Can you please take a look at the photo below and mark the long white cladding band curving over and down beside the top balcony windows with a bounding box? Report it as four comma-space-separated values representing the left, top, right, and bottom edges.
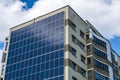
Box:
90, 29, 112, 62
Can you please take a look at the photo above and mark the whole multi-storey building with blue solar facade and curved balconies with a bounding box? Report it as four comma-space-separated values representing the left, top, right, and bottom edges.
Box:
0, 6, 120, 80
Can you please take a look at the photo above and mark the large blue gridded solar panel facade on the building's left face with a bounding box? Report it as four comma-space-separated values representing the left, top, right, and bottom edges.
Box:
5, 12, 64, 80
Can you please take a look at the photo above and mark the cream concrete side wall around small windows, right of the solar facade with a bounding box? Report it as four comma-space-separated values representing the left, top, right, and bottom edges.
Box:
65, 8, 87, 80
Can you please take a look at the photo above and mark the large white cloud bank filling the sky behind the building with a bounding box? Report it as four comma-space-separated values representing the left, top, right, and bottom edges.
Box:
0, 0, 120, 41
